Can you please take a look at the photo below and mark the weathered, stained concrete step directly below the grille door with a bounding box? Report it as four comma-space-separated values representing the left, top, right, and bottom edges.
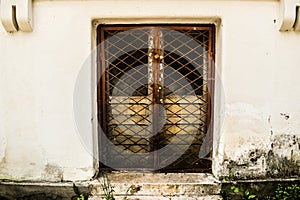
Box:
89, 173, 222, 200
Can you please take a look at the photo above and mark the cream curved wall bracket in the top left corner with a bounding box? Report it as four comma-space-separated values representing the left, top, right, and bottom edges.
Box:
0, 0, 32, 32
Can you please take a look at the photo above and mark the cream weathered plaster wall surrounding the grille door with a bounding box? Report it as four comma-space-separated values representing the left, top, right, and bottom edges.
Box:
0, 0, 300, 181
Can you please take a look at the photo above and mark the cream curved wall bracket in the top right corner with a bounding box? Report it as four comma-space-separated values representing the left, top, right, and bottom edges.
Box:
279, 0, 300, 31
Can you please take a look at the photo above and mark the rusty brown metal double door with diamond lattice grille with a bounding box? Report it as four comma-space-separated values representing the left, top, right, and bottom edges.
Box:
98, 25, 214, 172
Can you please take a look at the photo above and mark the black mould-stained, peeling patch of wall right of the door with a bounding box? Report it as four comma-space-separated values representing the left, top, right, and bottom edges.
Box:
223, 134, 300, 180
